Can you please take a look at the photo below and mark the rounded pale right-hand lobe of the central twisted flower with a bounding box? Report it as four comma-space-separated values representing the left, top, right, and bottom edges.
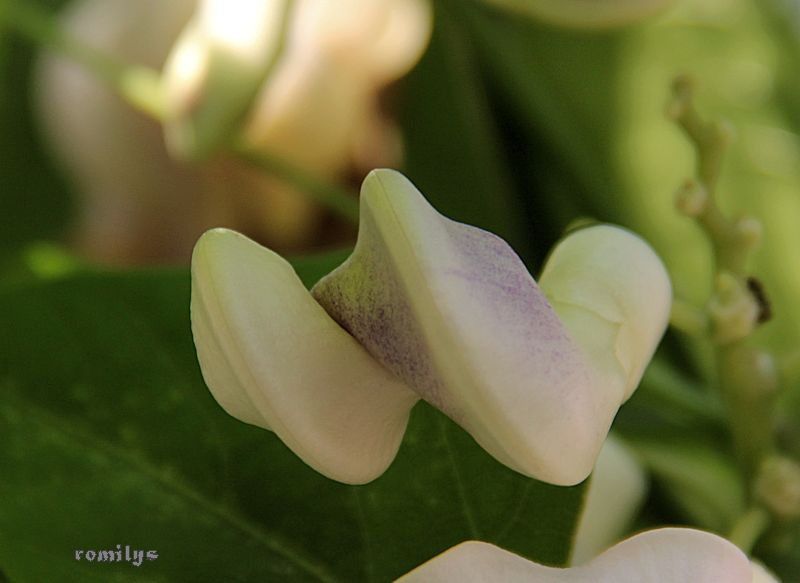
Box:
539, 225, 672, 402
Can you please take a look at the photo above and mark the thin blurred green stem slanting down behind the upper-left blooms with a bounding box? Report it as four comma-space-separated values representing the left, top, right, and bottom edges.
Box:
0, 0, 358, 225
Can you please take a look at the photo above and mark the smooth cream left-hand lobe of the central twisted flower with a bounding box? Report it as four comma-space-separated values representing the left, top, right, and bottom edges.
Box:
192, 229, 417, 483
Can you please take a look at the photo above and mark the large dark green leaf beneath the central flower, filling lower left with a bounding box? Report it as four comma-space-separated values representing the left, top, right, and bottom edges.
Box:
0, 254, 582, 583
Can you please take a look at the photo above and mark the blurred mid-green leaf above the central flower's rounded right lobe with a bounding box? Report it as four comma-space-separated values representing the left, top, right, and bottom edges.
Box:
463, 2, 619, 220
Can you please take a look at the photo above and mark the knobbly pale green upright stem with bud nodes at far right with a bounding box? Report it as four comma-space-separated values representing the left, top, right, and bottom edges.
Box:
668, 77, 778, 482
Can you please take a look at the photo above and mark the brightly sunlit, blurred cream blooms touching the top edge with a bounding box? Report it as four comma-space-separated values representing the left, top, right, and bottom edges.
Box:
164, 0, 432, 162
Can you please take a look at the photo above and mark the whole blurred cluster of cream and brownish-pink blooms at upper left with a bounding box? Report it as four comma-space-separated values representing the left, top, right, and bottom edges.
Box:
35, 0, 432, 263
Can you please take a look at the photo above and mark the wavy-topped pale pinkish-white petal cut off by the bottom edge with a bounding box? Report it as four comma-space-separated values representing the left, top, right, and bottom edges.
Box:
397, 528, 752, 583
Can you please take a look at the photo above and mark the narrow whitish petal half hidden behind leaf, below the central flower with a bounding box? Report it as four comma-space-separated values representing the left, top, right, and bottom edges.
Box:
572, 433, 647, 565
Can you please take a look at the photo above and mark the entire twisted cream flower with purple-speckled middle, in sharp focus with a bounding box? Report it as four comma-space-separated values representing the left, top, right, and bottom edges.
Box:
192, 170, 670, 484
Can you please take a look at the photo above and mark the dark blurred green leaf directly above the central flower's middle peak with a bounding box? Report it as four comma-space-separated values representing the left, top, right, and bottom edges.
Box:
403, 2, 529, 258
